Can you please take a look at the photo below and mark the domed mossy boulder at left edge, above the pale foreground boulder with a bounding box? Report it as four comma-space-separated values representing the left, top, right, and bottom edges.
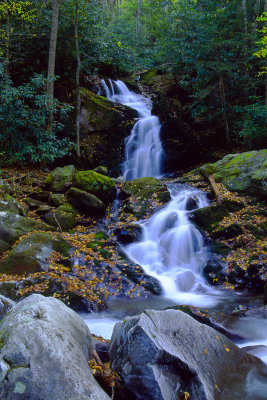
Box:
0, 232, 70, 275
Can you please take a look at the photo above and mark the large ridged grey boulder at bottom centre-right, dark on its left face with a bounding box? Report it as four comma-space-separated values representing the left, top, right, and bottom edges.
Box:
109, 310, 263, 400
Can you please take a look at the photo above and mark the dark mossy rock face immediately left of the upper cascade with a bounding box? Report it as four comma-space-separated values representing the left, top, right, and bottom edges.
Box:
80, 88, 137, 175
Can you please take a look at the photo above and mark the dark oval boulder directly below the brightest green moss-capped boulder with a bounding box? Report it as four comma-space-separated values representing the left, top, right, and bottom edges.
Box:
67, 188, 106, 216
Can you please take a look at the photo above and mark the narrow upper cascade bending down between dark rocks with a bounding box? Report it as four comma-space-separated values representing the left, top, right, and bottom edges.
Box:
102, 79, 163, 180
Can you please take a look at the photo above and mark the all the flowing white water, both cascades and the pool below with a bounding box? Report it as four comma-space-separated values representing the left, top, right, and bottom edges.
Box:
82, 80, 267, 400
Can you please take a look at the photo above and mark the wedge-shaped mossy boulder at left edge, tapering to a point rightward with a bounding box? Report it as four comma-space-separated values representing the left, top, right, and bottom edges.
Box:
0, 212, 54, 250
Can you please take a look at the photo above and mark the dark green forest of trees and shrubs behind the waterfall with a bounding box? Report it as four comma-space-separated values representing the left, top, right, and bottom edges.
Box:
0, 0, 267, 164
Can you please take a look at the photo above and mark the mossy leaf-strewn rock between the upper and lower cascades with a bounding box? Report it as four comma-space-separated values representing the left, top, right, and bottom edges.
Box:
121, 177, 171, 218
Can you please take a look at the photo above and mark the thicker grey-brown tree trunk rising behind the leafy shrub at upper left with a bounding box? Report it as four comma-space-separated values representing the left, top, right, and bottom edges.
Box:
47, 0, 61, 131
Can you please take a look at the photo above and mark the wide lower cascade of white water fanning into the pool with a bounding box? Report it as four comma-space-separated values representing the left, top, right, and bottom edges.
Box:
124, 185, 218, 304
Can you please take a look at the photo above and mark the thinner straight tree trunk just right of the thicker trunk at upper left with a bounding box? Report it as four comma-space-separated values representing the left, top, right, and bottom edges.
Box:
75, 0, 81, 158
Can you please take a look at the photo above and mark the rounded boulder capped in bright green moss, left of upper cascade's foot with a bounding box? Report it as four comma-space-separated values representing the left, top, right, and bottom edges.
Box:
73, 171, 116, 204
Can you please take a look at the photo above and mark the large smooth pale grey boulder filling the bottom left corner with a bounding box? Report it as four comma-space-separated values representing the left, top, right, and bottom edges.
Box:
0, 294, 110, 400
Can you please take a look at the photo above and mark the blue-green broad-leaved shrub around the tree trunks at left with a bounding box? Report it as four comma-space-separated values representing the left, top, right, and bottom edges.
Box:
0, 63, 70, 163
